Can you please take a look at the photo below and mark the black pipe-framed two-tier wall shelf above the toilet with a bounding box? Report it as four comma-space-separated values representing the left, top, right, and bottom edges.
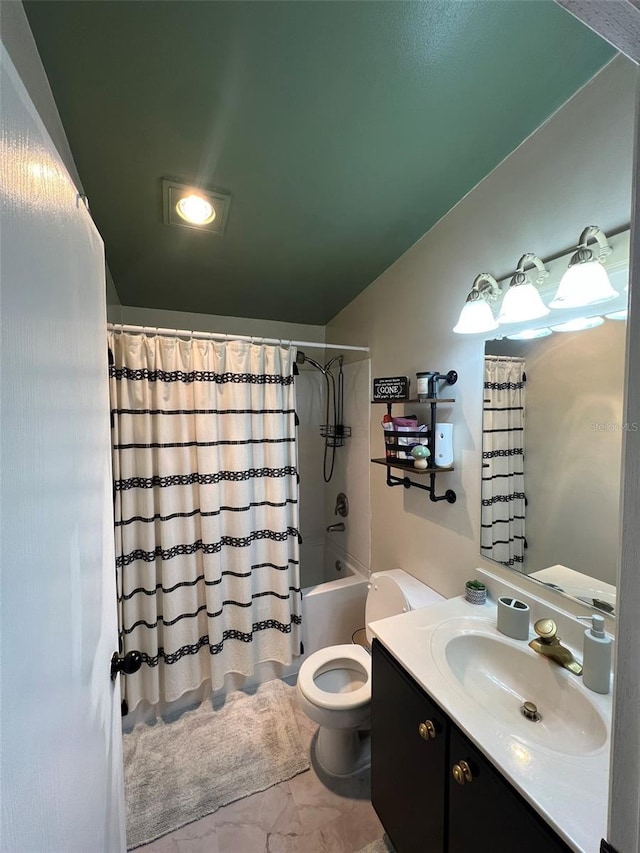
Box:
371, 370, 458, 504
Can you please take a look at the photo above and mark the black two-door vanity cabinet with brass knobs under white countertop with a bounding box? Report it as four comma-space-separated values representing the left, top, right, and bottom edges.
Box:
371, 640, 570, 853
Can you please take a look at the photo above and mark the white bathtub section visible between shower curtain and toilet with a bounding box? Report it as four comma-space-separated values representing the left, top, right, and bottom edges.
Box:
302, 541, 369, 656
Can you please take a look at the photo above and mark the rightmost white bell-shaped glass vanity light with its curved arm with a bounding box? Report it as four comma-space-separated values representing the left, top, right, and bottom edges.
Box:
549, 225, 618, 308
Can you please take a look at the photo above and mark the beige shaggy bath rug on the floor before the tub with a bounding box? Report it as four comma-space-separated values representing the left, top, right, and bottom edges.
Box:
123, 680, 309, 850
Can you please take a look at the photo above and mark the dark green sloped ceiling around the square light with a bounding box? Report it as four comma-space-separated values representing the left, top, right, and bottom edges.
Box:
25, 0, 613, 324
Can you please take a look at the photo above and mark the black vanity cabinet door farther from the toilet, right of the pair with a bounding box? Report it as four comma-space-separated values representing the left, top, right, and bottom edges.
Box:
448, 725, 570, 853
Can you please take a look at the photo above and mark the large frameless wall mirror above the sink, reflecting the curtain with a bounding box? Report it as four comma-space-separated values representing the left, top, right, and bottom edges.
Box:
480, 288, 624, 615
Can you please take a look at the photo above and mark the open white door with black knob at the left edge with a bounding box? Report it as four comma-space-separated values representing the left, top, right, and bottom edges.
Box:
0, 31, 126, 853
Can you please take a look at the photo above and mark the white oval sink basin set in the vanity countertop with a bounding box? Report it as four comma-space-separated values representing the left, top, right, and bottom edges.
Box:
432, 620, 607, 755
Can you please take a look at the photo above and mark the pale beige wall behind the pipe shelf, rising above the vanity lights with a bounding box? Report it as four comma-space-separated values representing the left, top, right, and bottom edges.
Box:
327, 57, 637, 596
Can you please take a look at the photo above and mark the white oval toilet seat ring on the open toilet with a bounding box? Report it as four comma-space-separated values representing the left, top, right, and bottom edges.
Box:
298, 643, 371, 711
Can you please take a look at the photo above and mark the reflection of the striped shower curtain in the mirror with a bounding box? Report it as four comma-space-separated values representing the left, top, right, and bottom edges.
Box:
480, 356, 526, 571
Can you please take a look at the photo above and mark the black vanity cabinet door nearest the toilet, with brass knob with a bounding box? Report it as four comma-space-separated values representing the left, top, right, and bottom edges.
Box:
371, 640, 444, 853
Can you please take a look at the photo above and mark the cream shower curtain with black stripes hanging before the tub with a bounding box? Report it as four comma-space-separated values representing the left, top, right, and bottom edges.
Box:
109, 332, 301, 711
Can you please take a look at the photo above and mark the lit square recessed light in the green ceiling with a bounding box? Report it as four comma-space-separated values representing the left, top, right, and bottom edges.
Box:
162, 178, 231, 234
